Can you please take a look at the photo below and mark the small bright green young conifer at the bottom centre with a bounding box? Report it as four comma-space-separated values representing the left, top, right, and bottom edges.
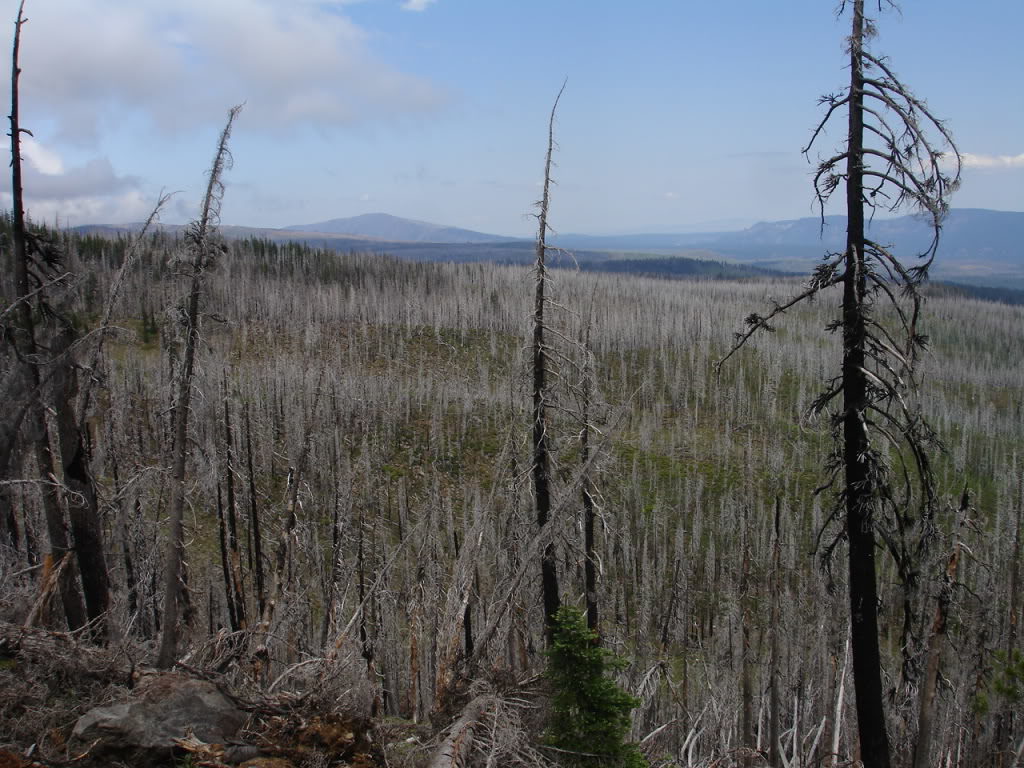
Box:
547, 606, 647, 768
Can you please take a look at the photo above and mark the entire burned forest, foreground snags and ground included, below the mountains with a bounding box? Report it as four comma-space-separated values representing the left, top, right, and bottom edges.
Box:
0, 0, 1024, 768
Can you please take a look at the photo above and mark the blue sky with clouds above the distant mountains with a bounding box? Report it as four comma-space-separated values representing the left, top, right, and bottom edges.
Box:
0, 0, 1024, 236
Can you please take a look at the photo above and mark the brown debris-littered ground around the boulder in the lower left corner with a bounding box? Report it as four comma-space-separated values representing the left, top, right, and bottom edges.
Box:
0, 624, 497, 768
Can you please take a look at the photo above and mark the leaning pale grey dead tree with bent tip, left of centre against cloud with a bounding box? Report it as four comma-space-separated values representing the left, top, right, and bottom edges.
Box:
157, 106, 242, 669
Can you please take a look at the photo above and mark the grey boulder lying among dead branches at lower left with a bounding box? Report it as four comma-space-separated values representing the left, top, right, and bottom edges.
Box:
72, 673, 246, 768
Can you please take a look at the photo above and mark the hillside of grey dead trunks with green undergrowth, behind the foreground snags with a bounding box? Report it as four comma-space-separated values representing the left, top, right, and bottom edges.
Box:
0, 215, 1024, 765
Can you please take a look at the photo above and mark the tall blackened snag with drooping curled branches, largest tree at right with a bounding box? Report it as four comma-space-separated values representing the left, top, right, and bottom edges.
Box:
719, 0, 959, 768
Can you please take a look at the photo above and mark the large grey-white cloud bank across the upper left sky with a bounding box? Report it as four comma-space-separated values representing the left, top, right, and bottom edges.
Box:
6, 0, 445, 145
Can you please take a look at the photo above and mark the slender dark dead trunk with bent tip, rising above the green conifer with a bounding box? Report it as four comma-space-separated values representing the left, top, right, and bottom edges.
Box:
532, 83, 565, 637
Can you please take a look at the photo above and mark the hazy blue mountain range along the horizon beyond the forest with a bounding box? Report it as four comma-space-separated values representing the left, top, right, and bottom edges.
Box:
76, 208, 1024, 291
